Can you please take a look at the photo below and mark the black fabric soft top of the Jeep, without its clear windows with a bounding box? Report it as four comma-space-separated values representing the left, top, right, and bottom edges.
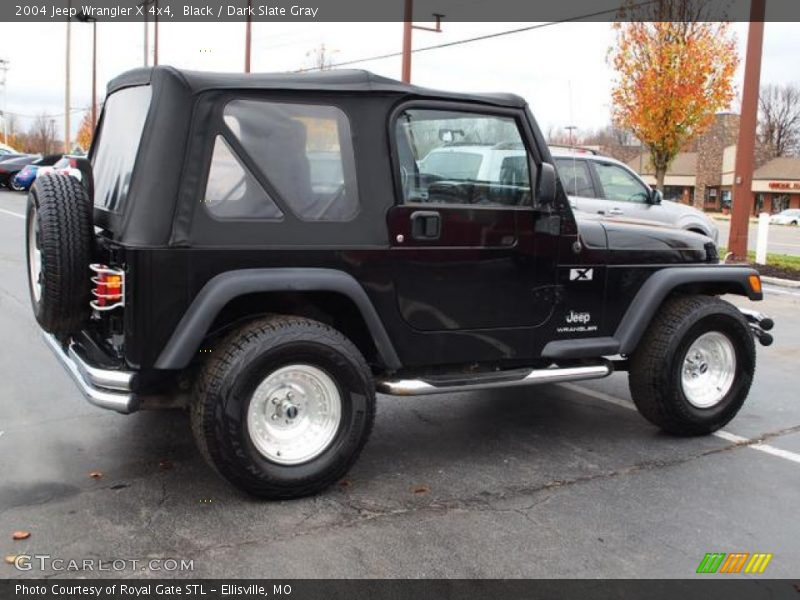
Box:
90, 66, 526, 247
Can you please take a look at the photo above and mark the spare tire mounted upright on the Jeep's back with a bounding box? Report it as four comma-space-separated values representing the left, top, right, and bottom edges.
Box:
25, 175, 93, 335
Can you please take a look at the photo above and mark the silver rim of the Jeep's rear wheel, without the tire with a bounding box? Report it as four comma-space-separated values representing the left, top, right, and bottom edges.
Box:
247, 365, 342, 465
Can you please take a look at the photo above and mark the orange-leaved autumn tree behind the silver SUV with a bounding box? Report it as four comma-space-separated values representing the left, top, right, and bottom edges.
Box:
610, 17, 739, 191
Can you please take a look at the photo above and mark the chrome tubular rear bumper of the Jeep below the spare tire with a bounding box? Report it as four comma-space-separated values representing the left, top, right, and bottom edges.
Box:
44, 334, 138, 414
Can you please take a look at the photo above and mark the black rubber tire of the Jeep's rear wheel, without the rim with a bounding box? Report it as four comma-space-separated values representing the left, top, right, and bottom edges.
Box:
190, 316, 375, 499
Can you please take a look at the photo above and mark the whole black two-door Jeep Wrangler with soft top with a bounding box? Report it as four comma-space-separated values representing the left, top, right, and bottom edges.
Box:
27, 67, 772, 498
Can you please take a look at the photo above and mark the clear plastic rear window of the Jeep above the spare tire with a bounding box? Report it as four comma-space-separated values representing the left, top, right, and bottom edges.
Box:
92, 86, 151, 212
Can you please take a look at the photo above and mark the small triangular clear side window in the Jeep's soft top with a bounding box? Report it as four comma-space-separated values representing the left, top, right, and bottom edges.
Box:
203, 135, 283, 219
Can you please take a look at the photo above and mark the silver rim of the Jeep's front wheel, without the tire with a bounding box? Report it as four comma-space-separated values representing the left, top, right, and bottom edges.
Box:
681, 331, 736, 408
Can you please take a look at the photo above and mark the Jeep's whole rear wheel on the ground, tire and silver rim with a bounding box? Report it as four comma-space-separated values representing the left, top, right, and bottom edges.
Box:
191, 317, 375, 499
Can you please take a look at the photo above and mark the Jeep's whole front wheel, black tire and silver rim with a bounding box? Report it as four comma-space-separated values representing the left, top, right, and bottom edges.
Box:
629, 296, 756, 435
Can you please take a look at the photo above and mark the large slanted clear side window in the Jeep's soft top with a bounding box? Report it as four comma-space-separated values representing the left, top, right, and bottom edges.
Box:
224, 100, 358, 221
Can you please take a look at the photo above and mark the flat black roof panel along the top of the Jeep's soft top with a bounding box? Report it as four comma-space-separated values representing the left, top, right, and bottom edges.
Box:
108, 66, 525, 108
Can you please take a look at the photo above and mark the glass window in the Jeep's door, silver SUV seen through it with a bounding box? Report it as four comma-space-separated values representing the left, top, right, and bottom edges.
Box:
395, 109, 532, 206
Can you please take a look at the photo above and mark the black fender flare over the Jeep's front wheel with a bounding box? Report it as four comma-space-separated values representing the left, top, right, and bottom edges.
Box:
542, 265, 764, 360
